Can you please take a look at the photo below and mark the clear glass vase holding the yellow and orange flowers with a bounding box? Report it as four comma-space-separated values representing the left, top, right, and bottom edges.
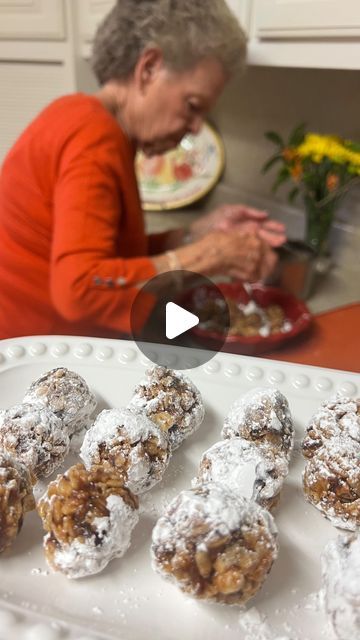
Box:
304, 196, 336, 257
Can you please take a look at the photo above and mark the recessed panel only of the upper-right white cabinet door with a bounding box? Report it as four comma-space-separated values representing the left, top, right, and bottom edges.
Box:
255, 0, 360, 39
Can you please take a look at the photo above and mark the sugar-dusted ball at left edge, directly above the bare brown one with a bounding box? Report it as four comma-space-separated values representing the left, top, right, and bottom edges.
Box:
0, 404, 69, 478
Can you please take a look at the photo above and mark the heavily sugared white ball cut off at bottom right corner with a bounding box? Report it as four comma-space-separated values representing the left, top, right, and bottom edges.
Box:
322, 534, 360, 640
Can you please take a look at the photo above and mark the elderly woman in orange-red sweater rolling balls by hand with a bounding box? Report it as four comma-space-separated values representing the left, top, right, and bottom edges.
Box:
0, 0, 284, 338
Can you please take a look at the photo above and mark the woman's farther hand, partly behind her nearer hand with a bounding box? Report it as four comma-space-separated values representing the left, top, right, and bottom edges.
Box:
189, 204, 286, 247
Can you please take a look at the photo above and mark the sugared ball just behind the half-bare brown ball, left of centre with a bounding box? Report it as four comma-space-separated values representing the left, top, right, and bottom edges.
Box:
80, 409, 170, 494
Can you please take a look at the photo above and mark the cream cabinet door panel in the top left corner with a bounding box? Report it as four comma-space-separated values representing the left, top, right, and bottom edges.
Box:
0, 0, 66, 40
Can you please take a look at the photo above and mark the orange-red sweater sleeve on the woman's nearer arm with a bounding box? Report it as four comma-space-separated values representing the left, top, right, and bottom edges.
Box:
50, 153, 155, 333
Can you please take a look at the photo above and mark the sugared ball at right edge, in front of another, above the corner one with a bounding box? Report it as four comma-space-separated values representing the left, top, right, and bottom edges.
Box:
303, 436, 360, 531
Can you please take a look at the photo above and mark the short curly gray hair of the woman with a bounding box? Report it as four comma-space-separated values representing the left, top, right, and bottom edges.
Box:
92, 0, 246, 85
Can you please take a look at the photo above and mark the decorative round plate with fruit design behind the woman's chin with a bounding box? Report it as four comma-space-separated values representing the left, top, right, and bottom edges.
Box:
135, 123, 225, 211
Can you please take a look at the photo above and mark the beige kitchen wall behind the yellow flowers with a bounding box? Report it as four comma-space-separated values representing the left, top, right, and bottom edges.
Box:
200, 67, 360, 265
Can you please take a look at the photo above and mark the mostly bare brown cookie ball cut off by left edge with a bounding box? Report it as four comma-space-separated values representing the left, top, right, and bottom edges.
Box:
0, 451, 35, 553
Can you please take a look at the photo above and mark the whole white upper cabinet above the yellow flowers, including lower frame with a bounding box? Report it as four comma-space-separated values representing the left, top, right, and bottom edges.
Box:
248, 0, 360, 69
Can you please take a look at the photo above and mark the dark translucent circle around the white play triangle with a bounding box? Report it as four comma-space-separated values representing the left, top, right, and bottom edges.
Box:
130, 270, 230, 370
